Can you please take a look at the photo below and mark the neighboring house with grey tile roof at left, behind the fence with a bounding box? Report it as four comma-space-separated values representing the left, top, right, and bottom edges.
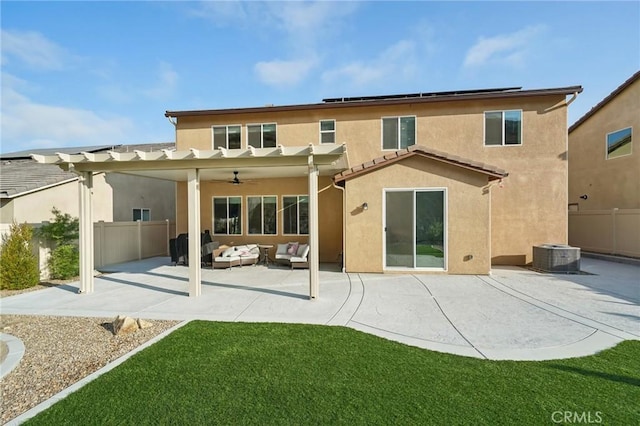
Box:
0, 143, 175, 228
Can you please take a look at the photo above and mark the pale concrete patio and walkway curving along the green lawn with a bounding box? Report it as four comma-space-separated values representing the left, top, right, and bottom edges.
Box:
0, 258, 640, 360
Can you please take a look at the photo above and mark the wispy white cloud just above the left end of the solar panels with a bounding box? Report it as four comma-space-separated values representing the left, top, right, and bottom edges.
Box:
322, 40, 418, 87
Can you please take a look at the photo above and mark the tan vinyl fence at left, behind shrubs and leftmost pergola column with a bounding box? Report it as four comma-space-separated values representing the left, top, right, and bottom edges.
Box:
0, 220, 176, 279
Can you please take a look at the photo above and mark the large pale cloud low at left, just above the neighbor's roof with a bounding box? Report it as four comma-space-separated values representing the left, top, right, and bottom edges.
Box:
0, 74, 134, 152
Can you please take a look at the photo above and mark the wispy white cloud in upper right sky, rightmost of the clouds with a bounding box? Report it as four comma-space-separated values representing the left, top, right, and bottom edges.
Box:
464, 25, 545, 68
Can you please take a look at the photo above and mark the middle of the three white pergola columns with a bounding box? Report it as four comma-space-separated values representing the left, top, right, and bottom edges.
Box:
187, 169, 202, 297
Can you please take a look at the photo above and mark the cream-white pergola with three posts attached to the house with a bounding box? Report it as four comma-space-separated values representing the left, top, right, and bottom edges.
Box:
32, 144, 348, 300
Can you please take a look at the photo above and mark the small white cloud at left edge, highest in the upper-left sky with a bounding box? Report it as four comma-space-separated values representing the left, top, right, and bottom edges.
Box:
1, 30, 69, 70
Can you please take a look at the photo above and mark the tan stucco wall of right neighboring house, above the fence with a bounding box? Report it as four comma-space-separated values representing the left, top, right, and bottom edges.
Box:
569, 80, 640, 210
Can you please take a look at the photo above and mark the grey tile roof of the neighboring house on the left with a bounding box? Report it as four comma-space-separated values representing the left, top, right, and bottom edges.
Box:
0, 142, 175, 198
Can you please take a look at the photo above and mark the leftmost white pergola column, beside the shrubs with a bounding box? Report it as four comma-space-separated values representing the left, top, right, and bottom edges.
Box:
78, 172, 94, 293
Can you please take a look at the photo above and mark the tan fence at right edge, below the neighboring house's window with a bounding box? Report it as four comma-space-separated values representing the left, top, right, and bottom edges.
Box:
569, 209, 640, 257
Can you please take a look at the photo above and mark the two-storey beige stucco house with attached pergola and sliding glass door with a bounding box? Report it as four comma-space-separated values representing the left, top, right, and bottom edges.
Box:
36, 86, 582, 298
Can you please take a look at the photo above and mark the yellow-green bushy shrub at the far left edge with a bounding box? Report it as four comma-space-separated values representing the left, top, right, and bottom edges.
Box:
0, 222, 40, 290
